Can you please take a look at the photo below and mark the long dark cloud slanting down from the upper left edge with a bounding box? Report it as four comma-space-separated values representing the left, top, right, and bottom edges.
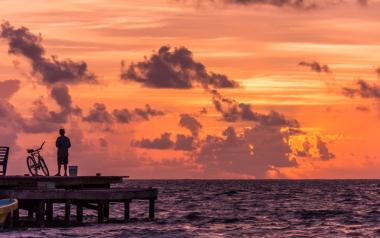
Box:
0, 22, 96, 85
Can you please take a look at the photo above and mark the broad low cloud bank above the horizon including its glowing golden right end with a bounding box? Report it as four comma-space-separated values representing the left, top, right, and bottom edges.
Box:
194, 125, 335, 178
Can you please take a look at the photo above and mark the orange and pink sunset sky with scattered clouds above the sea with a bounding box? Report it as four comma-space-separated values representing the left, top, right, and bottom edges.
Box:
0, 0, 380, 179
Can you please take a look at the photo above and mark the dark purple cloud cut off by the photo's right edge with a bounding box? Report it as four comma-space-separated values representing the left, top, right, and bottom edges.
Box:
343, 80, 380, 99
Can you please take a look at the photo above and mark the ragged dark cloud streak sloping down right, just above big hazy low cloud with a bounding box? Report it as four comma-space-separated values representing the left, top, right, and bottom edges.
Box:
211, 90, 299, 127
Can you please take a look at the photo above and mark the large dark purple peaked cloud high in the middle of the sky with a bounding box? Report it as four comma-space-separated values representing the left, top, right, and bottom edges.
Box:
121, 46, 239, 89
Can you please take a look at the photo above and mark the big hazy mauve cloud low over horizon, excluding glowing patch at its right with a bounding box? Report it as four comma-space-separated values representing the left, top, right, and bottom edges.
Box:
196, 125, 297, 178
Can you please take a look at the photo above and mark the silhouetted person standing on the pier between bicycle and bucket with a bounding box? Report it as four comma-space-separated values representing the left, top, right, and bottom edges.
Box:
55, 128, 71, 176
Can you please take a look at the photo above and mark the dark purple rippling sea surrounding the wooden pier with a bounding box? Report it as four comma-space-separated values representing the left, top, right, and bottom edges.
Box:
0, 180, 380, 238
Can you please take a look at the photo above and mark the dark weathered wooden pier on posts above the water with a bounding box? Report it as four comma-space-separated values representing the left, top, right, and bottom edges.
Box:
0, 176, 158, 226
